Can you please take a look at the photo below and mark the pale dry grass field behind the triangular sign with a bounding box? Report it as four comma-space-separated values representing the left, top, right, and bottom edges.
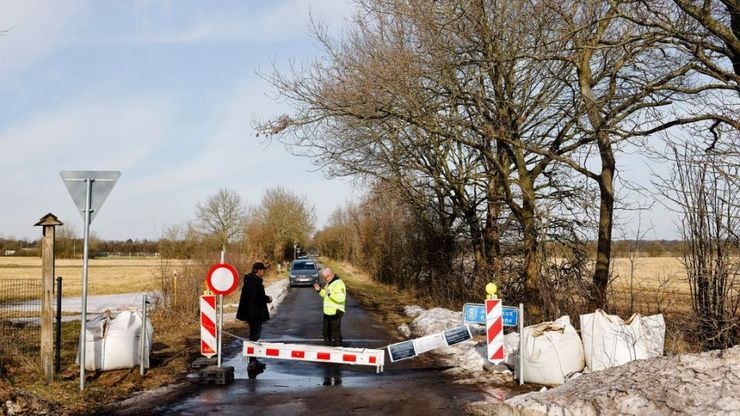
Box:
0, 257, 189, 296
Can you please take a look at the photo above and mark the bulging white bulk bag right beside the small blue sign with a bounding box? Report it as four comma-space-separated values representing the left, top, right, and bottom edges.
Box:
522, 316, 585, 385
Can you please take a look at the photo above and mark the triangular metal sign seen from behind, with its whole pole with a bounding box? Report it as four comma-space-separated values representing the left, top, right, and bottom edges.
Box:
59, 170, 121, 390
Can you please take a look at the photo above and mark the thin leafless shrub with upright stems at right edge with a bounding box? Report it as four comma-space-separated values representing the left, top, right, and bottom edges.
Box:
658, 138, 740, 349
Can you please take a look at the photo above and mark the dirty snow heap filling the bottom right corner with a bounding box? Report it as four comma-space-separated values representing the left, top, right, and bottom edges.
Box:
485, 346, 740, 416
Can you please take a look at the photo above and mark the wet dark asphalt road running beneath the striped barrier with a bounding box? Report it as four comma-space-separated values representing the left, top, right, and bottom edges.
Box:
148, 288, 483, 415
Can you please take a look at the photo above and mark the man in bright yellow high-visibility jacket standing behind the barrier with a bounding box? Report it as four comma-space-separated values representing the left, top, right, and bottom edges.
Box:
313, 267, 347, 347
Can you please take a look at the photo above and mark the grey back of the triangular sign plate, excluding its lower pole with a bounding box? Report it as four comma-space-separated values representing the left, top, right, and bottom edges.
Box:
59, 170, 121, 222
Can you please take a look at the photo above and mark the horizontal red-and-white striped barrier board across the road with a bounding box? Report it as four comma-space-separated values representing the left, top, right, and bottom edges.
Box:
244, 341, 385, 373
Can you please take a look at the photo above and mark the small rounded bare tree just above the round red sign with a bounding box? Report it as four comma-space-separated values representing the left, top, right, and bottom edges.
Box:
196, 189, 246, 250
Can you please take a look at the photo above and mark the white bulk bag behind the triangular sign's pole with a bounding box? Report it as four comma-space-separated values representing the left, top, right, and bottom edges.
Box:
77, 311, 154, 371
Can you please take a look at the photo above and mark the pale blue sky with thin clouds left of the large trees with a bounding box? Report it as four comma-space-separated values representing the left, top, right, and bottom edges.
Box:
0, 0, 360, 239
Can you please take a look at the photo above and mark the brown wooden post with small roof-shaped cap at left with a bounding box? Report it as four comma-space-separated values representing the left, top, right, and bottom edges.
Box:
35, 214, 62, 384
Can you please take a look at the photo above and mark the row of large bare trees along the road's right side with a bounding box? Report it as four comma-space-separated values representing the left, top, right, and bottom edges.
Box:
260, 0, 740, 350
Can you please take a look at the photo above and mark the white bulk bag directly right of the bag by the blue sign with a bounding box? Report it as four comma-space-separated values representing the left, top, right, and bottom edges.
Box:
581, 309, 648, 371
